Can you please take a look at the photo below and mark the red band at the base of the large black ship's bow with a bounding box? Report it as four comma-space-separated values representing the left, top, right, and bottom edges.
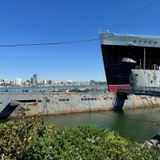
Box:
108, 84, 131, 92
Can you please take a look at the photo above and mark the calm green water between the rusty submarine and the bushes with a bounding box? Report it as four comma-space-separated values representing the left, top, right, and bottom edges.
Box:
43, 109, 160, 142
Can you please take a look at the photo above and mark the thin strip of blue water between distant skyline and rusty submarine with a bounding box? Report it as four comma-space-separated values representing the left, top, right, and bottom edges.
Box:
0, 85, 107, 92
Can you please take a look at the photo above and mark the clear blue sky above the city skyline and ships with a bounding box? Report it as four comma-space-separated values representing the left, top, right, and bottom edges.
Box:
0, 0, 160, 81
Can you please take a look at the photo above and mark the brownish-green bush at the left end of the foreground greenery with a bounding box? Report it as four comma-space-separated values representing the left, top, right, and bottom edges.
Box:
0, 118, 54, 159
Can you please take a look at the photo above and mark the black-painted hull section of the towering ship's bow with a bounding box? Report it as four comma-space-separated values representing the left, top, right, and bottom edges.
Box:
101, 44, 160, 91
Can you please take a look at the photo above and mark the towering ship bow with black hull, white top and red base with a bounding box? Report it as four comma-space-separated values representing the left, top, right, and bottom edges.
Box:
100, 31, 160, 92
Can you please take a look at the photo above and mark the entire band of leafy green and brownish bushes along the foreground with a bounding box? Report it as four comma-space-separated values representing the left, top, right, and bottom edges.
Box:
0, 118, 160, 160
